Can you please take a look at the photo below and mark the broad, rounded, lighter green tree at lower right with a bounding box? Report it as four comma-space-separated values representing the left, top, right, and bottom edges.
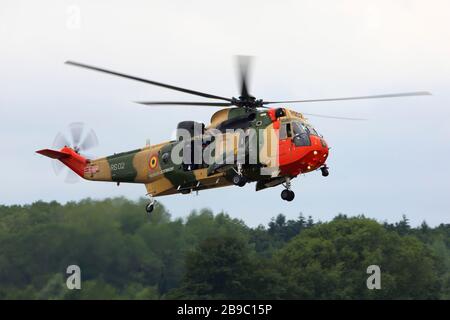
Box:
276, 218, 438, 299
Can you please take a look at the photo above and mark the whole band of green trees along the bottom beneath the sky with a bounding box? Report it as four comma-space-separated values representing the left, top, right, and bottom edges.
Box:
0, 198, 450, 299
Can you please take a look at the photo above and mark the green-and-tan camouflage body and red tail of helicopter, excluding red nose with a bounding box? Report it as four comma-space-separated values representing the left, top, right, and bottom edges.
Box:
38, 108, 324, 197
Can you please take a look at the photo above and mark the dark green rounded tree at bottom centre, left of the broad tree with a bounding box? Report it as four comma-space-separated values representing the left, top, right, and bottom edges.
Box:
172, 236, 277, 299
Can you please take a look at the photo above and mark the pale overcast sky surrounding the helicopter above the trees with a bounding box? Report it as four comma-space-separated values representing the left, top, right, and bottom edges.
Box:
0, 0, 450, 226
